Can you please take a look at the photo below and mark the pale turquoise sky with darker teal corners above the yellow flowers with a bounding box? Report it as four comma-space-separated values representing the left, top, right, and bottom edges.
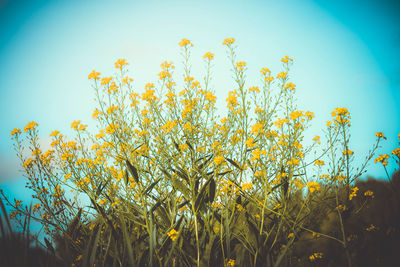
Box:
0, 0, 400, 202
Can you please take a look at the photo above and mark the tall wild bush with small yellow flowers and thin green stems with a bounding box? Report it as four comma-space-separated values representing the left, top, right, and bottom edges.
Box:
3, 38, 400, 266
